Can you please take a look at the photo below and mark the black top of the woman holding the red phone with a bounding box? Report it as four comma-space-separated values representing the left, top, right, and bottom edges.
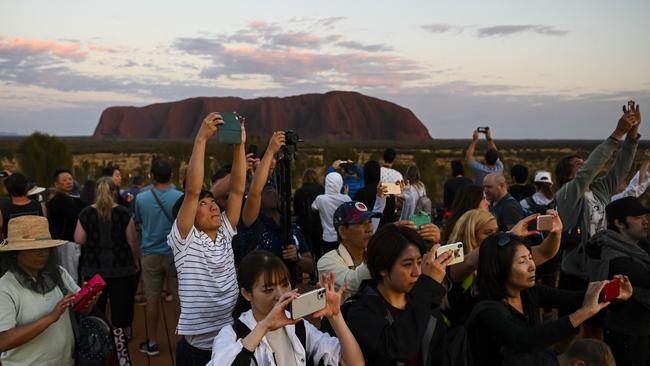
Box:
468, 285, 584, 366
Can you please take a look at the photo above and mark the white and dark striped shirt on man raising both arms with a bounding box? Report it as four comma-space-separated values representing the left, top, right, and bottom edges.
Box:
167, 214, 239, 350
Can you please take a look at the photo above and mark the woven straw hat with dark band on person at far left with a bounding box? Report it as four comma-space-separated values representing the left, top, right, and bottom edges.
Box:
0, 215, 67, 252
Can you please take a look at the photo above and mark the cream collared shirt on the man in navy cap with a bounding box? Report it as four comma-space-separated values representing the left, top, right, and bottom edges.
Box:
317, 244, 371, 303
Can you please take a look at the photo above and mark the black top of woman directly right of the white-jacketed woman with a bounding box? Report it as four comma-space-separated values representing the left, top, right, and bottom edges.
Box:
346, 275, 446, 366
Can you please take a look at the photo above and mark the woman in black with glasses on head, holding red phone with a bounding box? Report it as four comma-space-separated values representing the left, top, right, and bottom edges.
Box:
468, 233, 632, 366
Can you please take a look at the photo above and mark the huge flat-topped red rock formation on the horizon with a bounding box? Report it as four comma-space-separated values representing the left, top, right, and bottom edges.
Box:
93, 91, 431, 141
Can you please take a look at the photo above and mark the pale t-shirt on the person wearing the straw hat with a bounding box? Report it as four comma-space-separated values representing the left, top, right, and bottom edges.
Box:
0, 267, 79, 366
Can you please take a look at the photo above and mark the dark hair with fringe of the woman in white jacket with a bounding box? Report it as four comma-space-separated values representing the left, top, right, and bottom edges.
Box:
232, 250, 291, 319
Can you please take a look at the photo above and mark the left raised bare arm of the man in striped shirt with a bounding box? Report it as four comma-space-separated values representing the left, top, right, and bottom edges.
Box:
176, 113, 223, 239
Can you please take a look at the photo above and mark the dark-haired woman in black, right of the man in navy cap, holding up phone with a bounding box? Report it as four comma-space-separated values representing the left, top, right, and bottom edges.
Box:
346, 224, 453, 366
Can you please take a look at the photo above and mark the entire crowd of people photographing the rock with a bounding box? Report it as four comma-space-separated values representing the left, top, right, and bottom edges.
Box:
0, 102, 650, 366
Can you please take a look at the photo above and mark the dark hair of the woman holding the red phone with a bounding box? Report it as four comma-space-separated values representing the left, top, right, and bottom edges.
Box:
476, 233, 530, 301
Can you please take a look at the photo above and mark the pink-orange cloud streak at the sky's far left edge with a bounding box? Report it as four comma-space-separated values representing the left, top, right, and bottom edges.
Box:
0, 38, 88, 61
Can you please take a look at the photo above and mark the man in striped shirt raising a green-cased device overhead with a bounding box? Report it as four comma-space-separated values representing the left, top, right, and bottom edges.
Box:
168, 113, 246, 366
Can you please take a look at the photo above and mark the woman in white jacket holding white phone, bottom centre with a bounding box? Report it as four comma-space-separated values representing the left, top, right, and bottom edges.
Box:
208, 250, 364, 366
